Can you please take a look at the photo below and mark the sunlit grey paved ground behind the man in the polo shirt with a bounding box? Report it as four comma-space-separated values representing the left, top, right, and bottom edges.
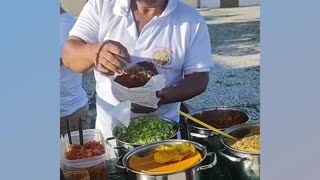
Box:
84, 6, 260, 124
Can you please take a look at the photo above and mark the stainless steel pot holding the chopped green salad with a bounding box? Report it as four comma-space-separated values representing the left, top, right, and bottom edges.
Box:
106, 116, 180, 156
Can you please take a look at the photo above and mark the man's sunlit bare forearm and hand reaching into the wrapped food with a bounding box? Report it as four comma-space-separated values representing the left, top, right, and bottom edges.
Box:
62, 36, 130, 75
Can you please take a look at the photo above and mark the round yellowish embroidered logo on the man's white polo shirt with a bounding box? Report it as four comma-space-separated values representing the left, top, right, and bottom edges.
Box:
152, 48, 171, 67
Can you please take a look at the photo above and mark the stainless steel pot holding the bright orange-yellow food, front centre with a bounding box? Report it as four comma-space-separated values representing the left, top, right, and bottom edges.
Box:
118, 139, 217, 180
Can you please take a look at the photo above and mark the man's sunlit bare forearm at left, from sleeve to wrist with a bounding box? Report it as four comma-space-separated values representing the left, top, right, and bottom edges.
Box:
62, 38, 99, 73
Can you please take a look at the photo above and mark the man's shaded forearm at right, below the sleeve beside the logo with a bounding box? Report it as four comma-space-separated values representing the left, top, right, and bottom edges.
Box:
157, 72, 209, 105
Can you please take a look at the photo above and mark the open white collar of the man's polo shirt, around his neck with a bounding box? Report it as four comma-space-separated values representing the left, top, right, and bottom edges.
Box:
113, 0, 178, 17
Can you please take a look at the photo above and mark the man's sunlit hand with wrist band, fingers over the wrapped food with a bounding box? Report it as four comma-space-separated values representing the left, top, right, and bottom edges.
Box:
94, 40, 130, 76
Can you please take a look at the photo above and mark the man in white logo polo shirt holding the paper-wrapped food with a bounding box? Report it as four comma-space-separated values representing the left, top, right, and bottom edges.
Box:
64, 0, 213, 138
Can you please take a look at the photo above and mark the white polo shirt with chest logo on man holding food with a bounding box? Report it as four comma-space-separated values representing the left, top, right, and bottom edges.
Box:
69, 0, 213, 137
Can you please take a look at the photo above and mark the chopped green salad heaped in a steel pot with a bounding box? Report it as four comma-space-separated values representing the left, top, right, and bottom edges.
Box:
116, 117, 176, 145
